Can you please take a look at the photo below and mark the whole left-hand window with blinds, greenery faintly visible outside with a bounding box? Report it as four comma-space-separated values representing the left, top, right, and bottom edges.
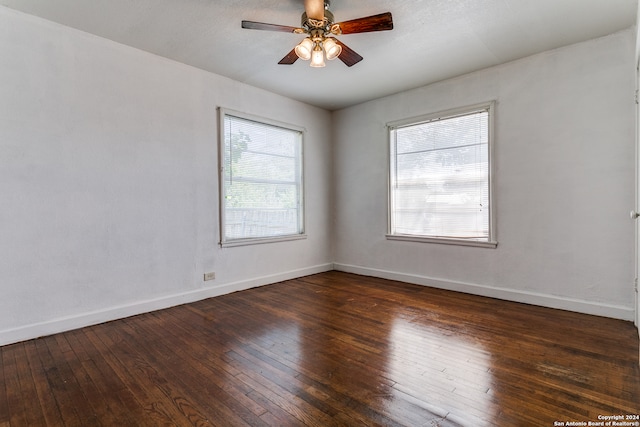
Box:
220, 109, 305, 246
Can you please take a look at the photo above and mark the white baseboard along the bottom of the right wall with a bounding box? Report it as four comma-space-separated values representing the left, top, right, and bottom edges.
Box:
334, 263, 635, 322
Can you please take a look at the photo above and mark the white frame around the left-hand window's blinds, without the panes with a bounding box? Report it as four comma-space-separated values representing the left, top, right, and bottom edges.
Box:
218, 107, 307, 247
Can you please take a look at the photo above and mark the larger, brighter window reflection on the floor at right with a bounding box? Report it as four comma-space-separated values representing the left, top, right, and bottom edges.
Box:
389, 318, 496, 426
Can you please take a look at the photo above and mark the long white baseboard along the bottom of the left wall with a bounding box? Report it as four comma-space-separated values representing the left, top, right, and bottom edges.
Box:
0, 263, 333, 346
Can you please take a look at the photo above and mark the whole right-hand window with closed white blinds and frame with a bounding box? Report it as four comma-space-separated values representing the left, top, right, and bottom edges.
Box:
387, 103, 496, 247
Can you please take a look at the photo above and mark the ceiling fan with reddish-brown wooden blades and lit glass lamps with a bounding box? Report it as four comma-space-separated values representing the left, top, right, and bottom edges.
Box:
242, 0, 393, 67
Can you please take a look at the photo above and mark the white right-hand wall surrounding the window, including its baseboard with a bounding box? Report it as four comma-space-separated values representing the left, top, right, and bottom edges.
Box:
333, 29, 635, 320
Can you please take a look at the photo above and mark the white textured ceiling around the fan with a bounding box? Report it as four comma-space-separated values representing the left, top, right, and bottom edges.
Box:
0, 0, 637, 110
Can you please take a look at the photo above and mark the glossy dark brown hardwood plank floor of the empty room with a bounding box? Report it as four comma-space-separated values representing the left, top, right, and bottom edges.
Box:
0, 272, 640, 427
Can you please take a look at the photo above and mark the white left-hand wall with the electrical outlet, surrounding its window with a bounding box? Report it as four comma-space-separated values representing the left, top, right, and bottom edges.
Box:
0, 8, 332, 344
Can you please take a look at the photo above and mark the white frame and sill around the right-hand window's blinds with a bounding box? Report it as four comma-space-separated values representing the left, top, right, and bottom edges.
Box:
386, 101, 498, 248
